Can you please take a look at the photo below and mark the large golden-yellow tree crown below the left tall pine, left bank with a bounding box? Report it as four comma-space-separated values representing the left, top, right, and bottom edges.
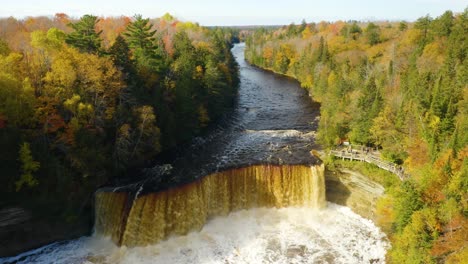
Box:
43, 48, 123, 128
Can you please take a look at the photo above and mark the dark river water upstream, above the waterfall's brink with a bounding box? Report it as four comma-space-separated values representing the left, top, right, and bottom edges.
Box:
114, 44, 320, 194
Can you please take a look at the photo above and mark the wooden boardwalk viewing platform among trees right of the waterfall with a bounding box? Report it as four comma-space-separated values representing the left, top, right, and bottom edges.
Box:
330, 145, 409, 181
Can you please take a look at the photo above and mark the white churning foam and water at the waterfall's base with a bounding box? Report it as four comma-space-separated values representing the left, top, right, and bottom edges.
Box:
0, 203, 389, 264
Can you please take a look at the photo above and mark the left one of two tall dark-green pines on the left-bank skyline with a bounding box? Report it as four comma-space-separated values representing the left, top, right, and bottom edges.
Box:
65, 15, 102, 54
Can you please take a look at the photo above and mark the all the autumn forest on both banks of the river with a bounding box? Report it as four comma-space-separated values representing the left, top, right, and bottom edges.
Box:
0, 6, 468, 263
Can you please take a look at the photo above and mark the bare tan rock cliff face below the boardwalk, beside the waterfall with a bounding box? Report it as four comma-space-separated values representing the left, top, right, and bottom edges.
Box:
325, 169, 385, 221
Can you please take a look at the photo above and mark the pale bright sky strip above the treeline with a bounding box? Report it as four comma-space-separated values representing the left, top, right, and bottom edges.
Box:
0, 0, 468, 26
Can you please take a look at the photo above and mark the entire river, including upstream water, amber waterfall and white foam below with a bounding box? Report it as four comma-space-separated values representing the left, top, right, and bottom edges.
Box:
0, 44, 389, 263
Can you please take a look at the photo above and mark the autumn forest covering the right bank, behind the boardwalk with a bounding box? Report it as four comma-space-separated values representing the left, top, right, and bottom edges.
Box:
246, 9, 468, 263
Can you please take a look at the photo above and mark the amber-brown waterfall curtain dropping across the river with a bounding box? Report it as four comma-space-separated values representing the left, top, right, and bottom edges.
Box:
95, 164, 326, 247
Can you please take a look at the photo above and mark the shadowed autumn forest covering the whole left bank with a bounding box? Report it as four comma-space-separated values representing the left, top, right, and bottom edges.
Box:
0, 13, 239, 239
